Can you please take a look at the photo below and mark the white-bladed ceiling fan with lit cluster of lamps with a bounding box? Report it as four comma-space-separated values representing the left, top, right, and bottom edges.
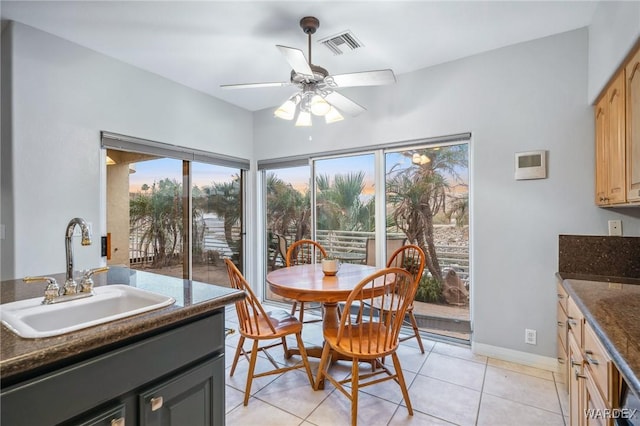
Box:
220, 16, 396, 126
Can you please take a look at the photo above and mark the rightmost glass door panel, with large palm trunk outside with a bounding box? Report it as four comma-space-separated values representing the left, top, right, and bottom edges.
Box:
385, 143, 471, 340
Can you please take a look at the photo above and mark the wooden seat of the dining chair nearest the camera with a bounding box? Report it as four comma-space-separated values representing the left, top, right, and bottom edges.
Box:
324, 322, 399, 359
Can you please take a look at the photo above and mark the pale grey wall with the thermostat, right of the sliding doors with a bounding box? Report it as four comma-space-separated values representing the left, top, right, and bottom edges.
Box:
254, 29, 640, 366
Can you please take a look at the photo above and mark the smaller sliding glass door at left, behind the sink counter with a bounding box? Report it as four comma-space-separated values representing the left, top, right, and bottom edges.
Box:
107, 149, 243, 285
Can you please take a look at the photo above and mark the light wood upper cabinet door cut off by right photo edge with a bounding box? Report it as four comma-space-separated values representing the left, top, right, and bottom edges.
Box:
625, 49, 640, 202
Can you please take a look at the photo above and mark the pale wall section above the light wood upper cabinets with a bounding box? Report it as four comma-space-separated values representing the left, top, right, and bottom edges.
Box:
589, 1, 640, 104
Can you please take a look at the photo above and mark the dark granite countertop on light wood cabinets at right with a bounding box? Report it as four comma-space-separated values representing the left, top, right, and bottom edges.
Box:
558, 273, 640, 395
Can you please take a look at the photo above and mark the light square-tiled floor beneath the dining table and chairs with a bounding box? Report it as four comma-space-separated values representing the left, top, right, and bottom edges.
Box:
226, 307, 569, 426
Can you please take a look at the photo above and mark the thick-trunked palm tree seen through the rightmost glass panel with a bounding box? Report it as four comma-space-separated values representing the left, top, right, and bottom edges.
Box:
387, 145, 468, 283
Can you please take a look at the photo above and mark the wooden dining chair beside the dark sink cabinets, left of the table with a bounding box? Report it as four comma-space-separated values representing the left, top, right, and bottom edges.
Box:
224, 259, 314, 405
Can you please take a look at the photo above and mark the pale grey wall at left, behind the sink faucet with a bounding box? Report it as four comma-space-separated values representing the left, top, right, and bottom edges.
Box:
2, 23, 253, 279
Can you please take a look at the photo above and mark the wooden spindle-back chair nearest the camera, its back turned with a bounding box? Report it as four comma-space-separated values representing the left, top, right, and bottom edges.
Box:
315, 268, 417, 426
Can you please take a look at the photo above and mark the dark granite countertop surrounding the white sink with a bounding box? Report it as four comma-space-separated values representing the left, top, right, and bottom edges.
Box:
0, 267, 244, 385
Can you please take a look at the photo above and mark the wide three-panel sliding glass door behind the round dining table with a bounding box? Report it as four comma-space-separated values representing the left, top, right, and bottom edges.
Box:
258, 140, 471, 340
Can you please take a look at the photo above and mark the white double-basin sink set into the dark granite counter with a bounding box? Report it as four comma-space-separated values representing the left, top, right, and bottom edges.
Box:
0, 284, 175, 338
